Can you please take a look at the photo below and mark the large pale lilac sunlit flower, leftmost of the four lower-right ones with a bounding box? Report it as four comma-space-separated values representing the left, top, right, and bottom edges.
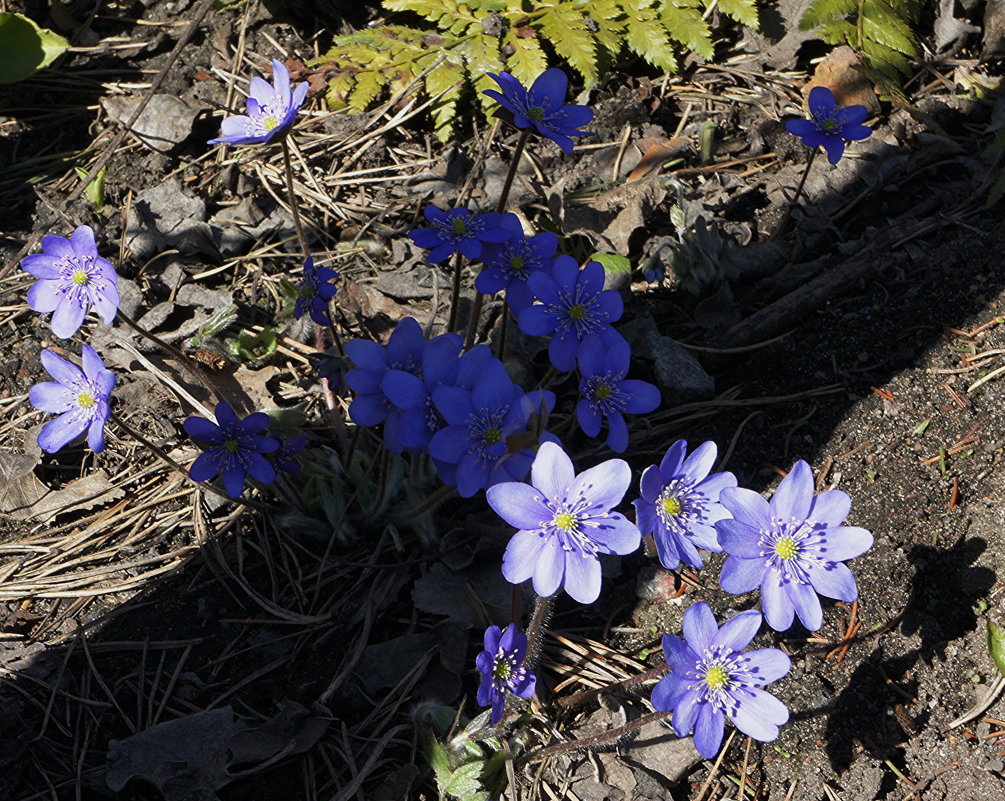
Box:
485, 442, 641, 604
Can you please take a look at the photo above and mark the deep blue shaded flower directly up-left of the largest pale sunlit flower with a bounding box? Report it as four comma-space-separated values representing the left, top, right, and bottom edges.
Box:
429, 358, 555, 497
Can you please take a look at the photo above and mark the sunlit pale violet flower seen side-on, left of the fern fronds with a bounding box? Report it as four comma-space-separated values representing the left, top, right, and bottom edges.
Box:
209, 58, 308, 145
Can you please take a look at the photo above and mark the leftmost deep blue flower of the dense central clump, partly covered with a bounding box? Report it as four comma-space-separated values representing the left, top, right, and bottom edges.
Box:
346, 317, 425, 453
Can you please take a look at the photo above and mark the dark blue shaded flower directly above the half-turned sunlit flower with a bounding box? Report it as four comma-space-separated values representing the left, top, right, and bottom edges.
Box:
576, 336, 659, 453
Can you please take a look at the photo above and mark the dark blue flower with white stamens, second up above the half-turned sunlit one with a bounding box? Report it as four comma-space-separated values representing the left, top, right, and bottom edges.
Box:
519, 255, 624, 373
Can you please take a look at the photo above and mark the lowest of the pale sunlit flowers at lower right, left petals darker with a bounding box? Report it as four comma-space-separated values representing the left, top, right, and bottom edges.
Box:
651, 602, 792, 759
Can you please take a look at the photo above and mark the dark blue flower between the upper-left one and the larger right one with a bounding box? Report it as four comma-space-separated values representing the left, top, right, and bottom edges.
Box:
474, 213, 559, 315
